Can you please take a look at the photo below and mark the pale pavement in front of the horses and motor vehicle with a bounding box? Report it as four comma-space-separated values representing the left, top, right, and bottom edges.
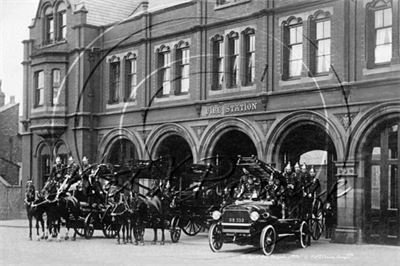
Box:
0, 220, 400, 266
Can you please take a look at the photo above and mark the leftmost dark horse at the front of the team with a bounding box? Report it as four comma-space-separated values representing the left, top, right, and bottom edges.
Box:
24, 180, 46, 240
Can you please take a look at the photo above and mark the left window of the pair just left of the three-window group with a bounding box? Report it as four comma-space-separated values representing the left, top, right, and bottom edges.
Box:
157, 46, 171, 96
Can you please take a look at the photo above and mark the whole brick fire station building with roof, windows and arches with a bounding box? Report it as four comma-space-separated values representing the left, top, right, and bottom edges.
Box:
21, 0, 400, 245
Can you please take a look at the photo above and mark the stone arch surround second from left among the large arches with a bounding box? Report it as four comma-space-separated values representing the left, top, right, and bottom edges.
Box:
144, 123, 198, 162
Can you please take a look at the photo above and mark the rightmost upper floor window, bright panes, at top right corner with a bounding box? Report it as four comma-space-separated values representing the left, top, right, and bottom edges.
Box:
366, 0, 393, 67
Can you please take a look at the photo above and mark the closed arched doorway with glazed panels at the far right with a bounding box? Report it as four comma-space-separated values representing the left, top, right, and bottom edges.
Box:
362, 120, 400, 245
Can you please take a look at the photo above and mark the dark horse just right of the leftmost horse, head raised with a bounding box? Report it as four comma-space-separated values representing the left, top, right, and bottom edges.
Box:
45, 181, 80, 241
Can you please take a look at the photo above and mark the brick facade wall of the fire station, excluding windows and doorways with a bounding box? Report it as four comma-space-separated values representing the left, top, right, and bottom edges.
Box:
22, 0, 400, 243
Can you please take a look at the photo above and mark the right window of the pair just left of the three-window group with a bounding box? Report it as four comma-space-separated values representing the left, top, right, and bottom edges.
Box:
175, 42, 190, 94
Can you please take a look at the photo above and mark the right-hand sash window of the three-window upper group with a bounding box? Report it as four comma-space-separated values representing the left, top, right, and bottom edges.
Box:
243, 29, 256, 85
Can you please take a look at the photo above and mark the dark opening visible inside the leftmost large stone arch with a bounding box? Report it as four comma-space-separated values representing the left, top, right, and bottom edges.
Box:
107, 138, 138, 165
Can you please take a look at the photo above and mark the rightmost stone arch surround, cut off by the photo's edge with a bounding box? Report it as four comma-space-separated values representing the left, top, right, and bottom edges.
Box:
348, 102, 400, 160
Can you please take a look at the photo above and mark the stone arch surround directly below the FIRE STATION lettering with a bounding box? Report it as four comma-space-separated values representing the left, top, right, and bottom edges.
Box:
199, 117, 264, 159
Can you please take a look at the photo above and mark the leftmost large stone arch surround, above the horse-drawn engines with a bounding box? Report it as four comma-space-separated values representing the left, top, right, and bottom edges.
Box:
97, 128, 144, 161
